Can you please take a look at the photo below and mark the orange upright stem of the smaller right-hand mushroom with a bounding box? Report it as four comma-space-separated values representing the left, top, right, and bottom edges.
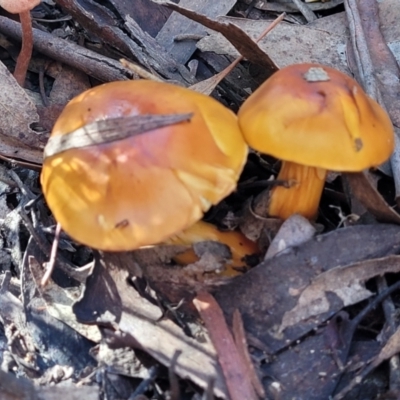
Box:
268, 161, 327, 219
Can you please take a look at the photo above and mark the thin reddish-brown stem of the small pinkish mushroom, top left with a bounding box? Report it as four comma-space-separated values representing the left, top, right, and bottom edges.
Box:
14, 10, 33, 86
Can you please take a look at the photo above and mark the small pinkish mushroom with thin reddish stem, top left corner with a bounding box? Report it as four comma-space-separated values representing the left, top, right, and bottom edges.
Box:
0, 0, 40, 86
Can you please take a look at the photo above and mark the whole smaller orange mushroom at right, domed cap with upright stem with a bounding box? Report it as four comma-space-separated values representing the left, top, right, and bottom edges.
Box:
238, 64, 394, 219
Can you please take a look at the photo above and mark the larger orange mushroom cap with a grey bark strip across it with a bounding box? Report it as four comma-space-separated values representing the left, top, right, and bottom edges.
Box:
41, 81, 247, 251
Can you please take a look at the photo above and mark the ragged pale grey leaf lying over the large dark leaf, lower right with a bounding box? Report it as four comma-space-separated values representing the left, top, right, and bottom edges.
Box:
279, 255, 400, 332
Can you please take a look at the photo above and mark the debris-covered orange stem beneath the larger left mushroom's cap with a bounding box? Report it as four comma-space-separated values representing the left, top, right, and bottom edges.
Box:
165, 221, 259, 275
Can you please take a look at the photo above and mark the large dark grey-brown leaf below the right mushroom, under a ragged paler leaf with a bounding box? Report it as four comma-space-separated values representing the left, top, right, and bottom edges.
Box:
214, 224, 400, 353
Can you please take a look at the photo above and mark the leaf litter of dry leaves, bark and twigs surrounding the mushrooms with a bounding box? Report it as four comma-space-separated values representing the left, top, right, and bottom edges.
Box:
0, 0, 400, 399
